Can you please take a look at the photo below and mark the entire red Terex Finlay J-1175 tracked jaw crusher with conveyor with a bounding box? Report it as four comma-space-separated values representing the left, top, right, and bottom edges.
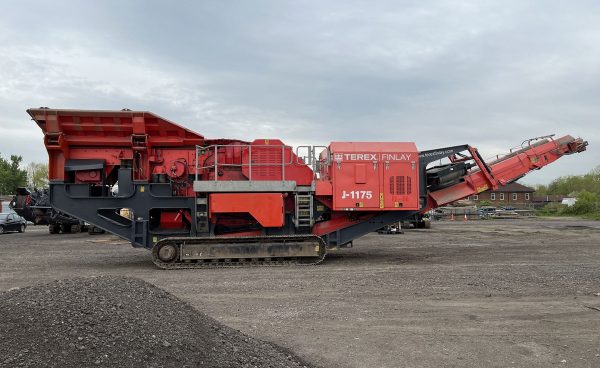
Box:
27, 108, 587, 268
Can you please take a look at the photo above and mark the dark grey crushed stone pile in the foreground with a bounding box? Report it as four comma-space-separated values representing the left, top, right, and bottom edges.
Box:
0, 276, 316, 368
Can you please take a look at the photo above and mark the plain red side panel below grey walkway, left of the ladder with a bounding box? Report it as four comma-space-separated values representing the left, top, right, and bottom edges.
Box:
208, 193, 284, 227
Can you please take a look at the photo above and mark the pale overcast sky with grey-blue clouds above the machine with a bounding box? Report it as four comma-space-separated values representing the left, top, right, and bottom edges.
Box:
0, 0, 600, 184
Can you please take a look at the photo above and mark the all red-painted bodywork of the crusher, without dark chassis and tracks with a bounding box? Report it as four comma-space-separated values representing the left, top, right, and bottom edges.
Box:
28, 108, 586, 240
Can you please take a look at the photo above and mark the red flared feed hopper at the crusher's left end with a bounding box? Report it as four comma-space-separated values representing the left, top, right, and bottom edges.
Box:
27, 109, 205, 182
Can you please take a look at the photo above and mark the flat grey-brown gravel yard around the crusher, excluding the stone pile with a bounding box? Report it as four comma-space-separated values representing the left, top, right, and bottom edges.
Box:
0, 219, 600, 368
